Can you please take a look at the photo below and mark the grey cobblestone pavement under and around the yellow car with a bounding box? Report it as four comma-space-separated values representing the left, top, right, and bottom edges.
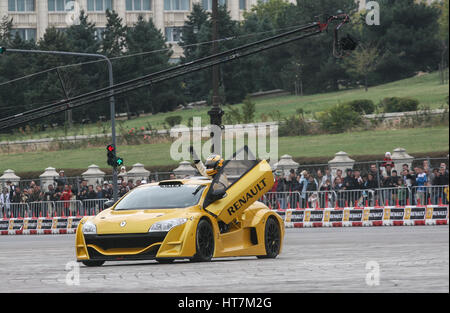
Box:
0, 226, 449, 292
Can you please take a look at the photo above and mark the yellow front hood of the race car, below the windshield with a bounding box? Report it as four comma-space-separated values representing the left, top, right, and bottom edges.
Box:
90, 208, 194, 235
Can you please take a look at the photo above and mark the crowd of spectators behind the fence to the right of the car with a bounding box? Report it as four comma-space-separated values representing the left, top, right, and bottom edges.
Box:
270, 152, 449, 208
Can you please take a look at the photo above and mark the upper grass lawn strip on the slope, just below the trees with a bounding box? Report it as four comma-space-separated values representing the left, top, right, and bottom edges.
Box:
0, 72, 449, 141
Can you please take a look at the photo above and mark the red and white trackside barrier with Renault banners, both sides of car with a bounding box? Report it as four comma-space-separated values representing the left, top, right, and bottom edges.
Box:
0, 205, 449, 235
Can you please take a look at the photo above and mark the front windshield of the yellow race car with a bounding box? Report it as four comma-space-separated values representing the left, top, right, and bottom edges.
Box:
115, 184, 205, 210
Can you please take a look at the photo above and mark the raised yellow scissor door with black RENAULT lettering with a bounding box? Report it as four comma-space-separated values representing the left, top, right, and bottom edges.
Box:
204, 147, 274, 224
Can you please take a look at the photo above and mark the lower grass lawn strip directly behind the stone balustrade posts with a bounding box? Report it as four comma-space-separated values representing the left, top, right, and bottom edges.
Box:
0, 127, 449, 173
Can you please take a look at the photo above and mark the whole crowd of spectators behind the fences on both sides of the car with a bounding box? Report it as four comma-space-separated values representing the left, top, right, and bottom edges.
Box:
0, 152, 449, 211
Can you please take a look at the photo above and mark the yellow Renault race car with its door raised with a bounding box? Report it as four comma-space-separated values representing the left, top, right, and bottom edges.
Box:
75, 154, 285, 266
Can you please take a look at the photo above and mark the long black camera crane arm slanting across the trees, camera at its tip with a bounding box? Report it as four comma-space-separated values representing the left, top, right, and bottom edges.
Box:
0, 14, 356, 129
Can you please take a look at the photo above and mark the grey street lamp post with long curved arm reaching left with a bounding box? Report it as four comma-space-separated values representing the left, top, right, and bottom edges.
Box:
1, 48, 118, 201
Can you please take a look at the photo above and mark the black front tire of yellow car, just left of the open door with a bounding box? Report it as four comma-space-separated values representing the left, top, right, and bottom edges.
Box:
191, 219, 215, 262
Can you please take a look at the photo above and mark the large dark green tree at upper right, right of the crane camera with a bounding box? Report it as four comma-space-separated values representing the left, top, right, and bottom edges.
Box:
361, 0, 441, 83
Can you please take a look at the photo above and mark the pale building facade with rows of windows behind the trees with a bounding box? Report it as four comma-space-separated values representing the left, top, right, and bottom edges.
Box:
0, 0, 295, 47
